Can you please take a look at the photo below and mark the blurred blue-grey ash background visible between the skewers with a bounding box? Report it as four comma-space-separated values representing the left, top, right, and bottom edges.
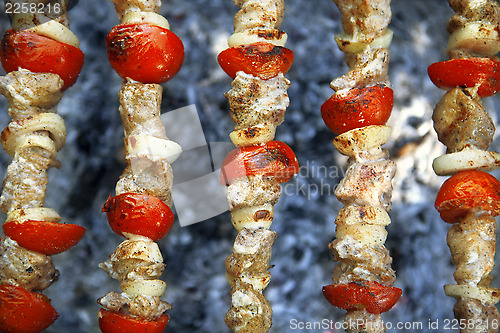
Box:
0, 0, 500, 333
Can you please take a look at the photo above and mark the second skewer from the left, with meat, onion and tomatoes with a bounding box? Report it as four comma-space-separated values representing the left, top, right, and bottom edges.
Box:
98, 0, 184, 333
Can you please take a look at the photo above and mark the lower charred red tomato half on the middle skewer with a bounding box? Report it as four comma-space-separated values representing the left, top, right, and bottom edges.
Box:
221, 141, 299, 185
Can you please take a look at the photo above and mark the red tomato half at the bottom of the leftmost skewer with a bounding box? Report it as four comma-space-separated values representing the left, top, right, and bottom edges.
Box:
0, 284, 59, 333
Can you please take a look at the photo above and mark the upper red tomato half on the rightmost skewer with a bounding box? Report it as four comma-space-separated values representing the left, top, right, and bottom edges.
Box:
427, 58, 500, 97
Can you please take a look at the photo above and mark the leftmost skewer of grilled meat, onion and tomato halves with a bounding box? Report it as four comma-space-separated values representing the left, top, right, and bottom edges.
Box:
0, 0, 85, 333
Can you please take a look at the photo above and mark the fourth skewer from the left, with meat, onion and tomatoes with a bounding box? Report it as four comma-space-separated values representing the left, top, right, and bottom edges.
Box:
321, 0, 402, 332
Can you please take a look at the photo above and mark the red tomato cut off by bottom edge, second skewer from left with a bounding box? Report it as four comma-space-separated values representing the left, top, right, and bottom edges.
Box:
98, 309, 169, 333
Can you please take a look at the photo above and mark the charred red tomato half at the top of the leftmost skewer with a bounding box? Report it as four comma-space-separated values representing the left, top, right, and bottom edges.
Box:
0, 30, 84, 90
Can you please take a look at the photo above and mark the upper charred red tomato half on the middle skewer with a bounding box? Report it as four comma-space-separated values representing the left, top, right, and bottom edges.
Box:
217, 42, 294, 80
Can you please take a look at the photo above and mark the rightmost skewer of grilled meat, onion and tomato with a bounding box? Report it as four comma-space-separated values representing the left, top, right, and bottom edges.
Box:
428, 0, 500, 332
